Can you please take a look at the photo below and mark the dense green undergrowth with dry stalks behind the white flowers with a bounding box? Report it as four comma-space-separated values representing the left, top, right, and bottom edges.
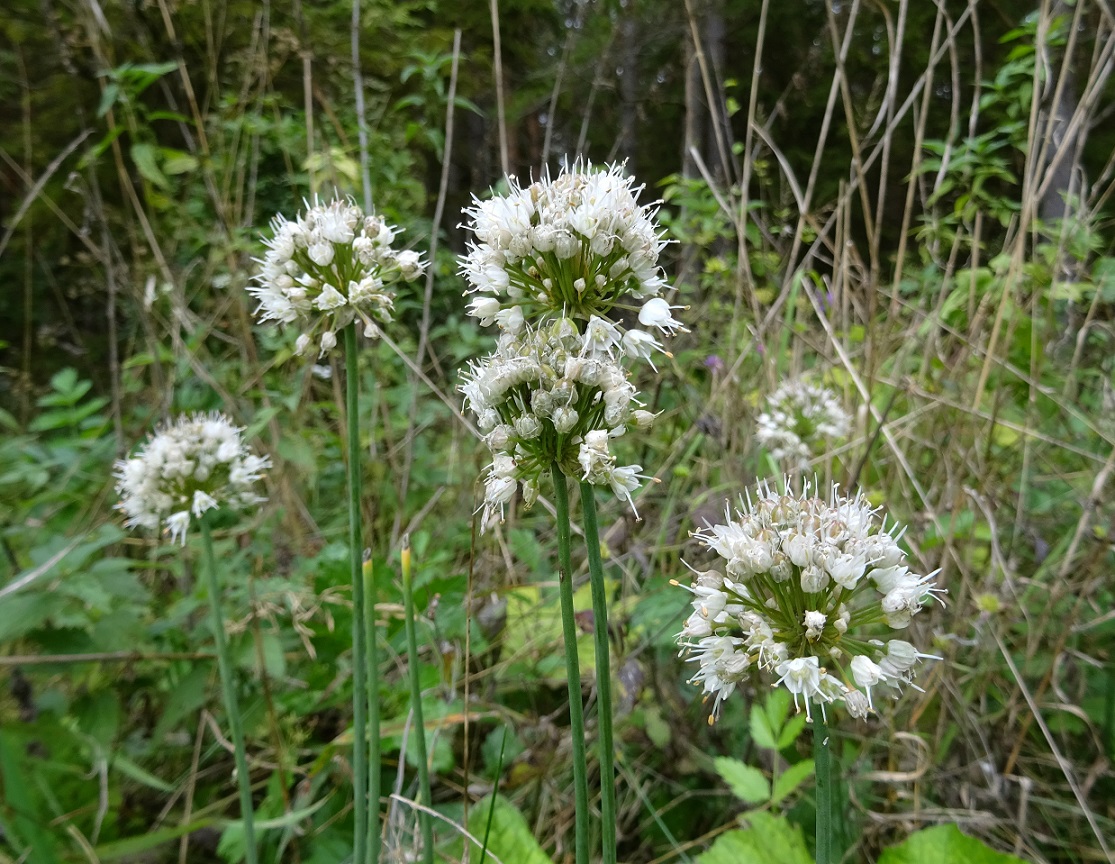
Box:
0, 0, 1115, 864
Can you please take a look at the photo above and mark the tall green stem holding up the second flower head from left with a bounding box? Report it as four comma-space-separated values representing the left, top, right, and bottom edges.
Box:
345, 323, 370, 864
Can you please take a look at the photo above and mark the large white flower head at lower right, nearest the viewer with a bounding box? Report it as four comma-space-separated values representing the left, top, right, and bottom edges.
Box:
675, 485, 944, 722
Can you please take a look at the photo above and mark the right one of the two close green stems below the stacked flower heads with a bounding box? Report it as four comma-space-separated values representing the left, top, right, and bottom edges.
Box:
581, 480, 615, 864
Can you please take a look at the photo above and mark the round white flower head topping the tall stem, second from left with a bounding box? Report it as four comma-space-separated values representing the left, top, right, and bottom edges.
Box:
248, 198, 426, 357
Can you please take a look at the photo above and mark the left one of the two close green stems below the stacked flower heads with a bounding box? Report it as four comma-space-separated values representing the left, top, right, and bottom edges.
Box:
550, 463, 589, 864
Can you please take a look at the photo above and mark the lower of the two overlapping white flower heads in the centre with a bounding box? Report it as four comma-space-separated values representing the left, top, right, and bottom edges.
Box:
460, 319, 653, 524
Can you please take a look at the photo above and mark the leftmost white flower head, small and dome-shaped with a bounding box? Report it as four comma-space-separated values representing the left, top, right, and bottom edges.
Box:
115, 412, 271, 544
